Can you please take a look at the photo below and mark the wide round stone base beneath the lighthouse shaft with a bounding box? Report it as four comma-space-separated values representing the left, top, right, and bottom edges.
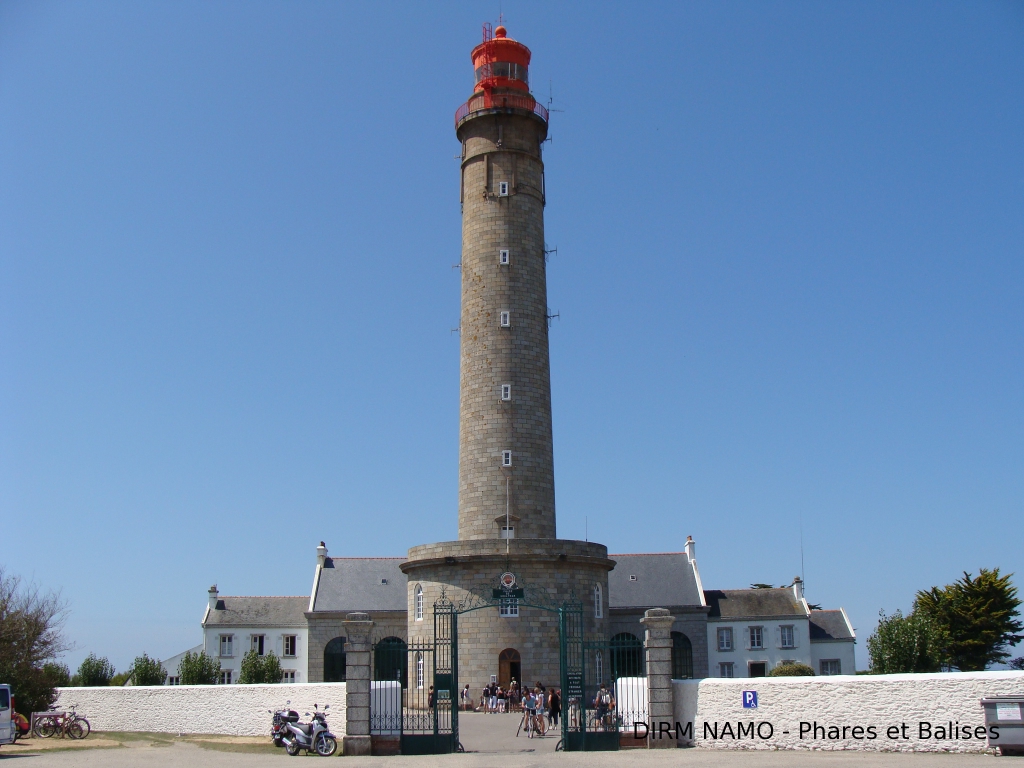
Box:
401, 539, 614, 702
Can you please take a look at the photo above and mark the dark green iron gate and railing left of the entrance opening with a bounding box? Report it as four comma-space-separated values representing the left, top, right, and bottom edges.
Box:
370, 598, 459, 755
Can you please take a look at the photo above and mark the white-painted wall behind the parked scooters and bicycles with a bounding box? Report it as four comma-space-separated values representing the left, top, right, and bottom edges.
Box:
56, 683, 345, 739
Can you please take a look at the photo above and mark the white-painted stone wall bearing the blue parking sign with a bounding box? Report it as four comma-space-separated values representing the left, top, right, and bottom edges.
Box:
672, 672, 1024, 753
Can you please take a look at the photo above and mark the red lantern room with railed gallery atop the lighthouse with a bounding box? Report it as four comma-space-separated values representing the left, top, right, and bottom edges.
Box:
455, 24, 548, 128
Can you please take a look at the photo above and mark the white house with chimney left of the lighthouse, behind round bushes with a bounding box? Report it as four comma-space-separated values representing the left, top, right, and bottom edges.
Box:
203, 585, 309, 685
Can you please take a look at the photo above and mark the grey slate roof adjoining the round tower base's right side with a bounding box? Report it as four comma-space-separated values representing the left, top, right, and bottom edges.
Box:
608, 552, 702, 608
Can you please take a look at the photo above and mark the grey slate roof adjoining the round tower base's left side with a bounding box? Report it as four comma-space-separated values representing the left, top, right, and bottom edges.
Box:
307, 557, 409, 611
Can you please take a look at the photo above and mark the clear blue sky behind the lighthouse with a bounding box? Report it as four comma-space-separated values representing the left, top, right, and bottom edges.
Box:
0, 0, 1024, 669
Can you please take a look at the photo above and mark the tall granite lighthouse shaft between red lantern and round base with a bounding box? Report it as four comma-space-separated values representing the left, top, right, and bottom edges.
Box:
458, 110, 555, 539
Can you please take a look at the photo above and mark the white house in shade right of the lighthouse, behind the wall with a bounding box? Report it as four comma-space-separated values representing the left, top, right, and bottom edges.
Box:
705, 579, 856, 678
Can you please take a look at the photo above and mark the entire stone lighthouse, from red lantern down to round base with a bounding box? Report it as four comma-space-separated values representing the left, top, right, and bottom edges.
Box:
401, 26, 614, 690
